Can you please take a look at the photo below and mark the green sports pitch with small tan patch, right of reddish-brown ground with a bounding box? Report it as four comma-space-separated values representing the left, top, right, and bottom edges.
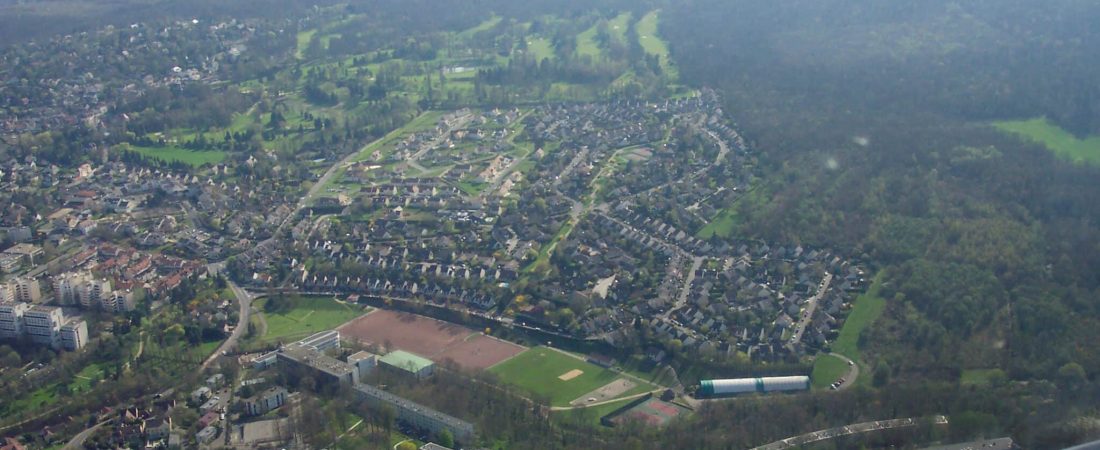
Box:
490, 347, 619, 406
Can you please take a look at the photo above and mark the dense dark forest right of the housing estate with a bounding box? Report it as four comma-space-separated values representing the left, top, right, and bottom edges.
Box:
662, 0, 1100, 447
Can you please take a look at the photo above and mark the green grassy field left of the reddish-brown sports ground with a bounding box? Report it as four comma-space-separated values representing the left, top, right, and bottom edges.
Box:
256, 297, 366, 342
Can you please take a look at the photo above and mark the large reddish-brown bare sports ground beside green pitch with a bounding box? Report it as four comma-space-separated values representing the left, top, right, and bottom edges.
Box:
338, 309, 527, 370
